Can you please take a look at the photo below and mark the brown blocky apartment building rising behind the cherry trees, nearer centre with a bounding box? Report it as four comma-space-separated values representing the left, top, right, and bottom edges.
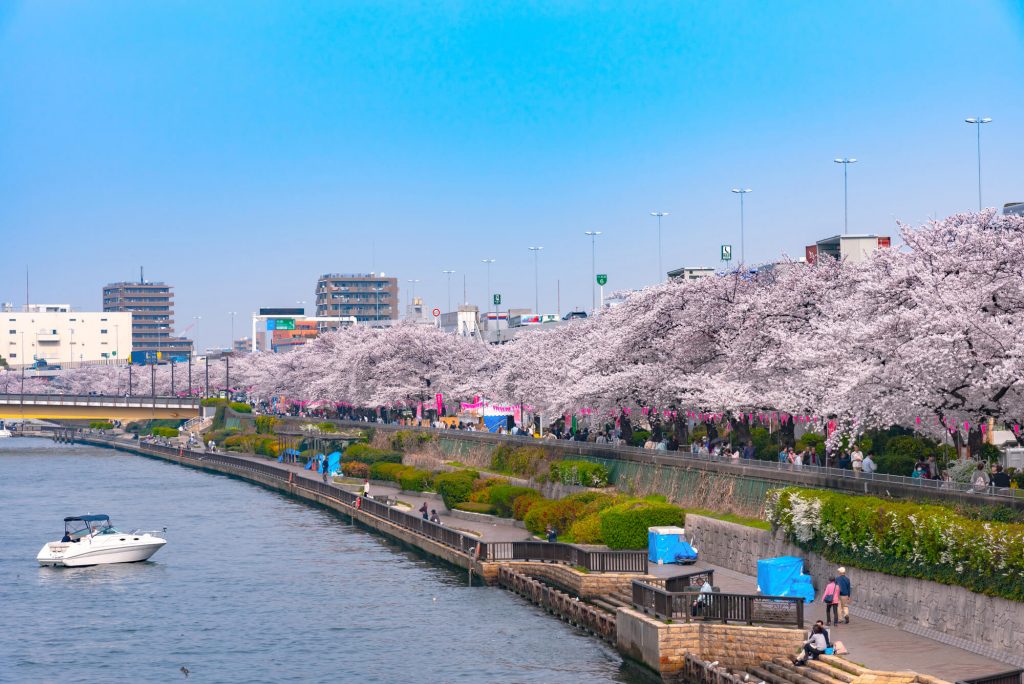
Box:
316, 273, 398, 322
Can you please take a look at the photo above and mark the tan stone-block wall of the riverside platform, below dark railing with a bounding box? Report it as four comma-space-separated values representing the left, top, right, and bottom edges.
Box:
615, 608, 806, 681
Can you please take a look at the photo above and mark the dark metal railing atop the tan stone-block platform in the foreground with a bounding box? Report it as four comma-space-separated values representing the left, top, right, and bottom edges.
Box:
632, 580, 804, 629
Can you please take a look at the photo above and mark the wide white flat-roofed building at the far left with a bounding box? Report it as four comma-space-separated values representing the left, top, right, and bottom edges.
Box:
0, 304, 132, 368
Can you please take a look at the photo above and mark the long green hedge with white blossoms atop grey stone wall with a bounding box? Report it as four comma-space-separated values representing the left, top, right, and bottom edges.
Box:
767, 487, 1024, 601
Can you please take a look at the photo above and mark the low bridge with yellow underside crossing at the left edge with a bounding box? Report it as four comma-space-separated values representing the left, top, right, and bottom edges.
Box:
0, 394, 200, 421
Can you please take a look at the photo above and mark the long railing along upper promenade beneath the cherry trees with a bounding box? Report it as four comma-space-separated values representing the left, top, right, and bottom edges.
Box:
325, 421, 1024, 501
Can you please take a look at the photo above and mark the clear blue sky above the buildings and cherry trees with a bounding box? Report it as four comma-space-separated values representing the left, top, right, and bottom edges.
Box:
0, 0, 1024, 346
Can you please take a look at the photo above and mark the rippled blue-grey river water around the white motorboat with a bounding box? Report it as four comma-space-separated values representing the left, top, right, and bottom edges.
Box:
0, 438, 647, 684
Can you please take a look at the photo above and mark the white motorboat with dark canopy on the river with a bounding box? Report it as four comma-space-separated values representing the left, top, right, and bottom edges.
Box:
36, 515, 167, 567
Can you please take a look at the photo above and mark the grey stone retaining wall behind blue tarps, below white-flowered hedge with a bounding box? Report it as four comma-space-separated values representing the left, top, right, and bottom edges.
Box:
686, 515, 1024, 667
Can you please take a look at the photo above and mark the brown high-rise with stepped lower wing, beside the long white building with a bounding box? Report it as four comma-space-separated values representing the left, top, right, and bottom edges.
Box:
103, 280, 193, 359
